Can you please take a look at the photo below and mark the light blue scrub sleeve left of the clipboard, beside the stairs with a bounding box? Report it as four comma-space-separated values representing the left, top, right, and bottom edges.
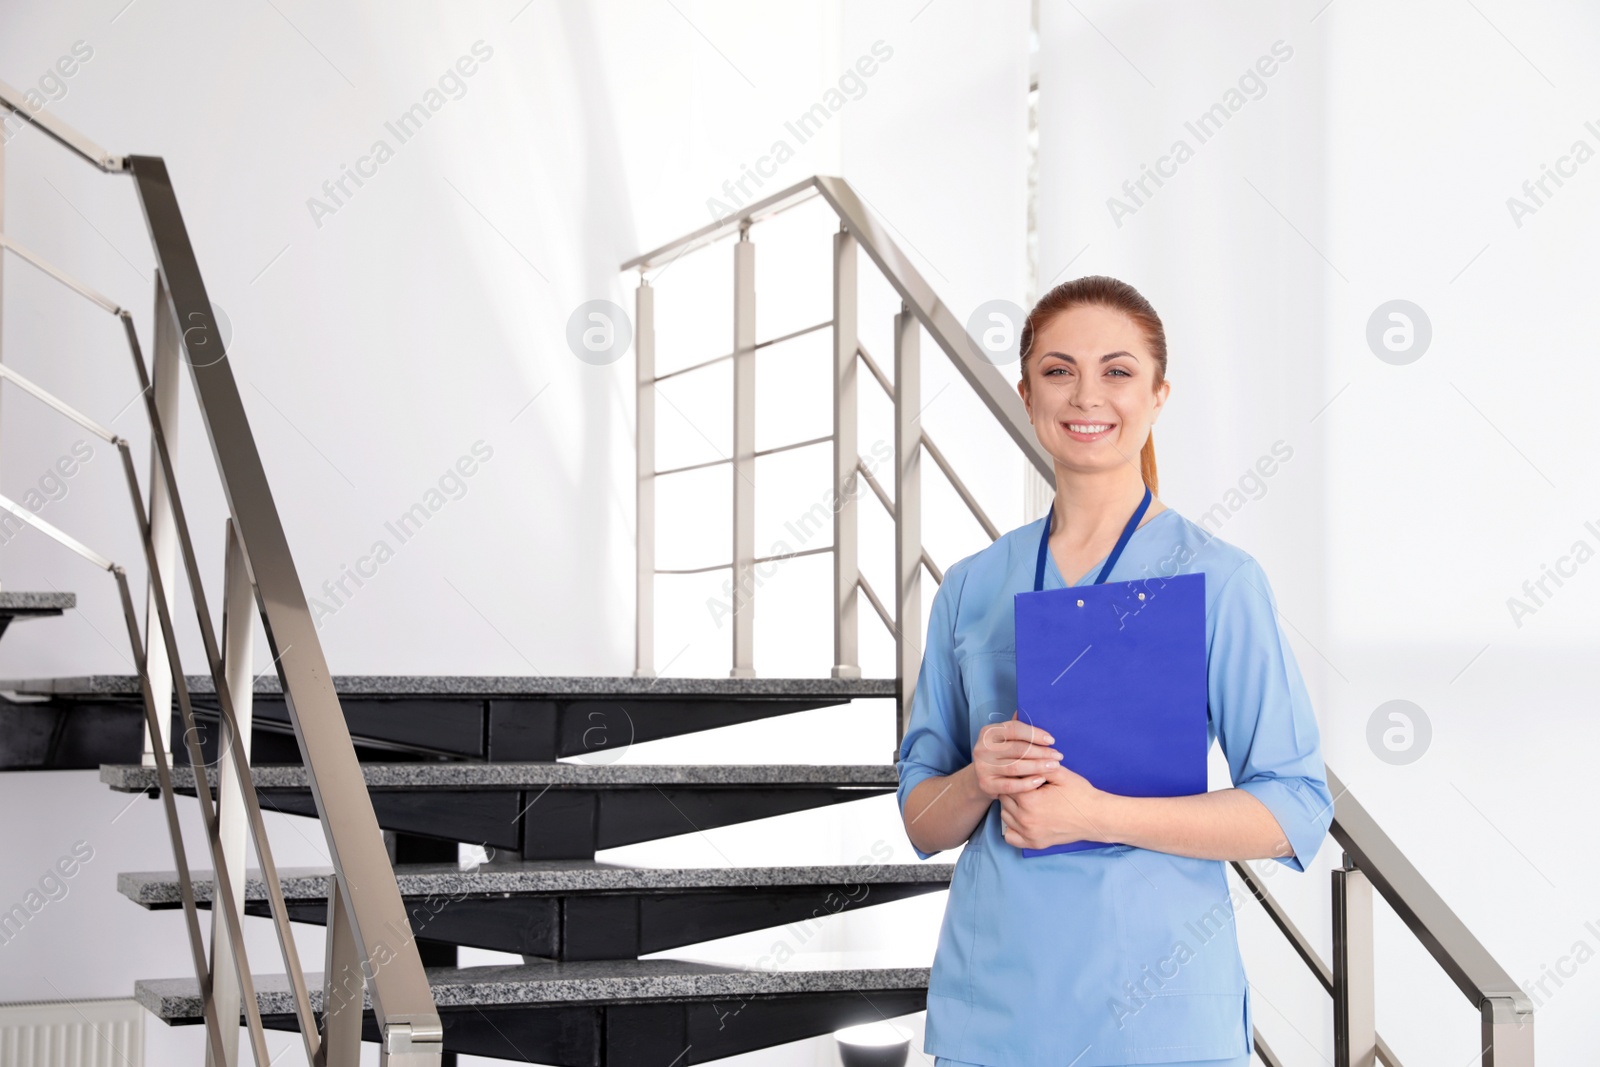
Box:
894, 563, 973, 859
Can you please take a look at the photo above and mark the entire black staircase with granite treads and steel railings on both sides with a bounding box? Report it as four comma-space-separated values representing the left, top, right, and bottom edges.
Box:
0, 83, 1534, 1067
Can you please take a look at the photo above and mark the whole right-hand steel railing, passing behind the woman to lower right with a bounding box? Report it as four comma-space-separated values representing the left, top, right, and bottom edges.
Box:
622, 176, 1533, 1067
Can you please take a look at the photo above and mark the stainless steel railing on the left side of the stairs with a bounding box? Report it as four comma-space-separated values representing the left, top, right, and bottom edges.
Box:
0, 83, 443, 1067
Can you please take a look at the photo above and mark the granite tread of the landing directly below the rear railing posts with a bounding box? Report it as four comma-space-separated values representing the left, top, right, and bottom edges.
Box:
0, 675, 898, 699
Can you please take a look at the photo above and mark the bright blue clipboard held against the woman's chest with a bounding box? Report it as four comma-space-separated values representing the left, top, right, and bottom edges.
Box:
1016, 573, 1208, 856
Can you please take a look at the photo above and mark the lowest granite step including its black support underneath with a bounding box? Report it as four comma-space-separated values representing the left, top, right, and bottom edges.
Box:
144, 953, 928, 1067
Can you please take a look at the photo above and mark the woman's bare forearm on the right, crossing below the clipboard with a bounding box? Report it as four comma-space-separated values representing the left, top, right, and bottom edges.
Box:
1091, 789, 1293, 859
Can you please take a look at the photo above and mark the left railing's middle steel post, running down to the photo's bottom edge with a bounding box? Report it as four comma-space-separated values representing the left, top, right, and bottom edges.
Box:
206, 520, 256, 1067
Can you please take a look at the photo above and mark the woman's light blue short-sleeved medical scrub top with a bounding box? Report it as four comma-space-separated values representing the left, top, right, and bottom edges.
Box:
896, 509, 1333, 1067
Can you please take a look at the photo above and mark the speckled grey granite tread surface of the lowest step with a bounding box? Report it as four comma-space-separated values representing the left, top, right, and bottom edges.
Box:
134, 952, 928, 1019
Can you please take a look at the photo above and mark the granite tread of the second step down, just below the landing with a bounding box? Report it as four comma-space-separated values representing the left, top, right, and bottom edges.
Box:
101, 761, 899, 792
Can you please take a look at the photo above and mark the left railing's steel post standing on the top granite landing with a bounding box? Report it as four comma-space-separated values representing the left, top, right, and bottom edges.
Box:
142, 272, 182, 766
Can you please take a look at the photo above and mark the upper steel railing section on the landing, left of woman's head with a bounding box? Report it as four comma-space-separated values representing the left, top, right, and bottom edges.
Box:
622, 176, 1036, 729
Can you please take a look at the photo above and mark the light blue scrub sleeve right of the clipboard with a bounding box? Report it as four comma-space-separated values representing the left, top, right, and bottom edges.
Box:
1206, 558, 1333, 870
